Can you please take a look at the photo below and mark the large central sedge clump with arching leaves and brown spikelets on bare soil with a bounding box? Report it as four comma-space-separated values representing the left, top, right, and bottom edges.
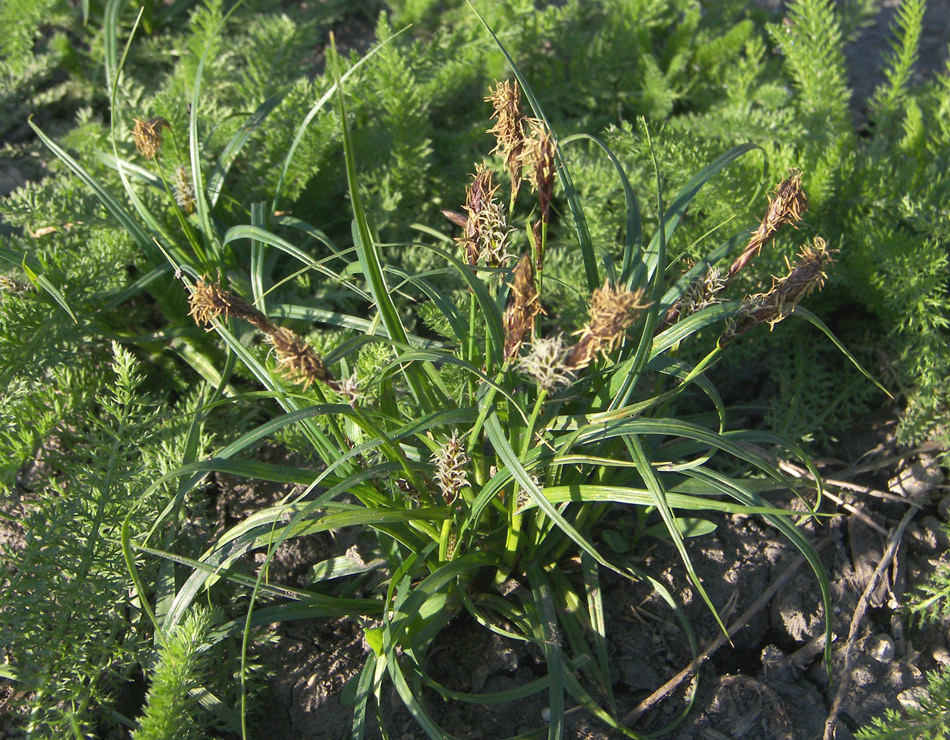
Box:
123, 23, 884, 738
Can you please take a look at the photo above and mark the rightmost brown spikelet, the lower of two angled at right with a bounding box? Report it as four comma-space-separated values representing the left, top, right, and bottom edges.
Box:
719, 236, 834, 345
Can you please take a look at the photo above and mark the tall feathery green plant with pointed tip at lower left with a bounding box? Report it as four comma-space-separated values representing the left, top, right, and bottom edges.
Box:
0, 345, 208, 737
